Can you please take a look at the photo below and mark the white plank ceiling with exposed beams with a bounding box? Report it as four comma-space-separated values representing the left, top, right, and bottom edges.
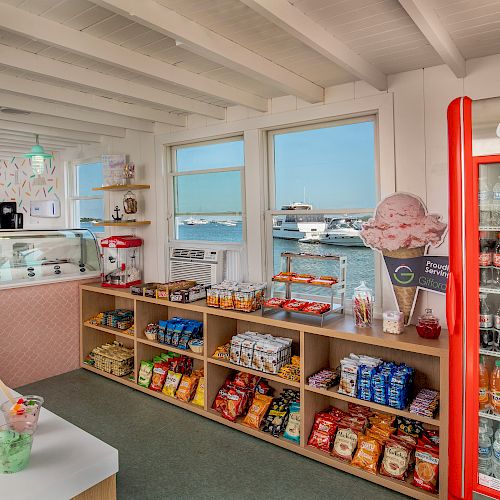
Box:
0, 0, 500, 154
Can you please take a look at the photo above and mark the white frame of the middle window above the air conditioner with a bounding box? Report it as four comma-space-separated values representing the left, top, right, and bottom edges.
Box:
165, 134, 247, 250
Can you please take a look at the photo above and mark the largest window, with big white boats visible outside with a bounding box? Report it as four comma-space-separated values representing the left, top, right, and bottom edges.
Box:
267, 117, 378, 299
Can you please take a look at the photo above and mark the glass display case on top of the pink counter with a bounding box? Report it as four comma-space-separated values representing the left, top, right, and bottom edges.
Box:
0, 229, 100, 289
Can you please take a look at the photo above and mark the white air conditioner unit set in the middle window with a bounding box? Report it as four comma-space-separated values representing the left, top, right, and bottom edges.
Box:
168, 247, 225, 285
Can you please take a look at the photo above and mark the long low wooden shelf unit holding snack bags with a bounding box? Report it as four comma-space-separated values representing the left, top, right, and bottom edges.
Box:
80, 284, 448, 499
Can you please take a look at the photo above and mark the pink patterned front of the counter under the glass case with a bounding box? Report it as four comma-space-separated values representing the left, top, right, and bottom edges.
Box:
0, 280, 95, 387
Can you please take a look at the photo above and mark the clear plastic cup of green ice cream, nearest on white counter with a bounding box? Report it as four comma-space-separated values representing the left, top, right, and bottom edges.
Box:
0, 424, 33, 474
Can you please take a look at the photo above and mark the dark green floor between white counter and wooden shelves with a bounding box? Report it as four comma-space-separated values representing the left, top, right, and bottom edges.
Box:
18, 370, 406, 500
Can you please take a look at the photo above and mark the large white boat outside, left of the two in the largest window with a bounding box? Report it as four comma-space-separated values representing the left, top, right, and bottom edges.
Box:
273, 202, 326, 243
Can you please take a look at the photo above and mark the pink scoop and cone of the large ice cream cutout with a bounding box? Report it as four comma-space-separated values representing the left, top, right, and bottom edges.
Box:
361, 193, 447, 324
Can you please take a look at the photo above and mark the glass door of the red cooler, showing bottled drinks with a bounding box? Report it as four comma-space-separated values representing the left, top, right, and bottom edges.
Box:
472, 156, 500, 492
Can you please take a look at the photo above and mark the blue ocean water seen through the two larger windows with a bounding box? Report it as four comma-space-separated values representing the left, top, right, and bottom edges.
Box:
178, 222, 375, 298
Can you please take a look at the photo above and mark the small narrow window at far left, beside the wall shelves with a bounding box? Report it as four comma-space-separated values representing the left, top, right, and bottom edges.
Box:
69, 160, 104, 233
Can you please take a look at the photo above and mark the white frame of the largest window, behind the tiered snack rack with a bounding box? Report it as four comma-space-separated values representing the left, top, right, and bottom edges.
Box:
264, 113, 383, 316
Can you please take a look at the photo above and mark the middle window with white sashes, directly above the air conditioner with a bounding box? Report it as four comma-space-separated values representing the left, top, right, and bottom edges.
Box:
169, 137, 245, 243
